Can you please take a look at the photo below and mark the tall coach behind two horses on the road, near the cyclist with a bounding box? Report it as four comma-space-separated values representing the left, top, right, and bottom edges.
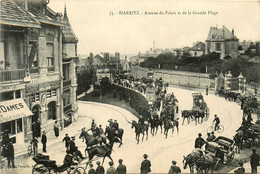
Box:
192, 93, 210, 121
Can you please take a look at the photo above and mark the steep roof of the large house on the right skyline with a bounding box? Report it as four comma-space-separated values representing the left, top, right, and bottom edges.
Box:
207, 25, 237, 40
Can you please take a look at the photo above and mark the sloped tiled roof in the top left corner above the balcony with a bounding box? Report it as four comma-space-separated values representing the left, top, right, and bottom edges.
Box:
0, 0, 41, 28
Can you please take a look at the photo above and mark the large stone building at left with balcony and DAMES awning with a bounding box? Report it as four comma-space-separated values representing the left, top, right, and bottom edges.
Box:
0, 0, 76, 144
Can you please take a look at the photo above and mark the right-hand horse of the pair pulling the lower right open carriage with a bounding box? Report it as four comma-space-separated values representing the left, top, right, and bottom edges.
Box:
195, 153, 217, 173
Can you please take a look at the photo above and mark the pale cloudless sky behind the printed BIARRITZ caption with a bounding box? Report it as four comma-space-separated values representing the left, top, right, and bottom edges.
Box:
48, 0, 260, 54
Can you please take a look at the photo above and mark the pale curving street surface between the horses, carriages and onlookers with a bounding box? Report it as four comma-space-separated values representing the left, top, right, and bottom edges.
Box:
1, 87, 251, 173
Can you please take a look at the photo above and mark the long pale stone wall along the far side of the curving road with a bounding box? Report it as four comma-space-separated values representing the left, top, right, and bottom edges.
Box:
131, 67, 212, 88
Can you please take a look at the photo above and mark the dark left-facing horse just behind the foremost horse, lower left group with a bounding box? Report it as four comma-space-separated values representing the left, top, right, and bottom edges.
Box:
79, 130, 107, 147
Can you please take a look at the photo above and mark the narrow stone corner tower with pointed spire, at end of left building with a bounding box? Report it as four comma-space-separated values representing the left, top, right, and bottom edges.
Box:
62, 6, 78, 126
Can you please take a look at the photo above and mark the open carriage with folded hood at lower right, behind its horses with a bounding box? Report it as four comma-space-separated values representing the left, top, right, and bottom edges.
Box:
205, 136, 235, 166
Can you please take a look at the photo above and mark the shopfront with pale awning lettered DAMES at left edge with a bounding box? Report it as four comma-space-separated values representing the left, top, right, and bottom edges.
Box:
0, 98, 33, 144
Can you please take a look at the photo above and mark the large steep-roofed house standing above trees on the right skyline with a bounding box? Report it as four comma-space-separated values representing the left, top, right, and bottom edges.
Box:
205, 25, 238, 59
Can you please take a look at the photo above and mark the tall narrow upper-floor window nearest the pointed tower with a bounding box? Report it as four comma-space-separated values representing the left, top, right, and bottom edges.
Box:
46, 34, 54, 72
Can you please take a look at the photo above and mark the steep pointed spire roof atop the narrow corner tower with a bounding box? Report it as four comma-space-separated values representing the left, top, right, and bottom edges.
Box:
62, 6, 78, 43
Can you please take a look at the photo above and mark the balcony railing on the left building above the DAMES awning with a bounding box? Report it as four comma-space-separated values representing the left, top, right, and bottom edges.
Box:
0, 69, 25, 82
